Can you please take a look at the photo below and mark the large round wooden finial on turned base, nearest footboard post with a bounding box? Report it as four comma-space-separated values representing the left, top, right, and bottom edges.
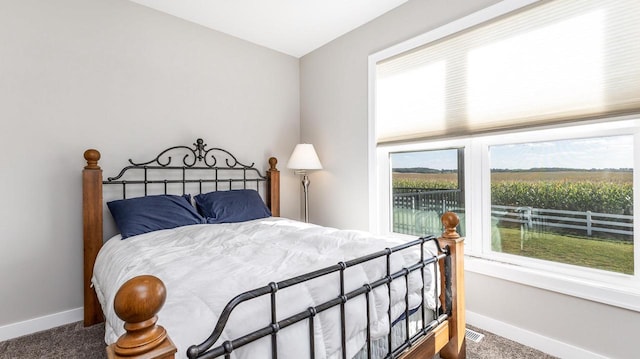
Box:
113, 275, 167, 356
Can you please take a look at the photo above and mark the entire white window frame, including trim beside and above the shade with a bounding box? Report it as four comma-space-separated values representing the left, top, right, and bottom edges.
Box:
368, 0, 640, 312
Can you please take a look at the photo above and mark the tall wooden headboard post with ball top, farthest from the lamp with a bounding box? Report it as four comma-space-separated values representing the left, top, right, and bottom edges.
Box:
82, 149, 104, 327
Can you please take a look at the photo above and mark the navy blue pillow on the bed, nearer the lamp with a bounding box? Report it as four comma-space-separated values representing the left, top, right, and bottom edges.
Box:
193, 189, 271, 224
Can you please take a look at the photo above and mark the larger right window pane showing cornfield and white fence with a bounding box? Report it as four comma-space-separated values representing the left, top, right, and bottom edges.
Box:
488, 135, 634, 274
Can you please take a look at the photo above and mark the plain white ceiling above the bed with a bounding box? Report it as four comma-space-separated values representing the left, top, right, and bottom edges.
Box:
131, 0, 408, 57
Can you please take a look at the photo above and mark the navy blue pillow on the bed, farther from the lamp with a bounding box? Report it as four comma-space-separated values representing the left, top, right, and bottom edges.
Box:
107, 195, 206, 239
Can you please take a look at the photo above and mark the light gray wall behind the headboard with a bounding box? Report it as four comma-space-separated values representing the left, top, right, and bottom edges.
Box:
0, 0, 300, 329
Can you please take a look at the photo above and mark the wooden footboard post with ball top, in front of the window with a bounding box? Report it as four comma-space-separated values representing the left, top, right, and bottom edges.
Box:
439, 212, 466, 359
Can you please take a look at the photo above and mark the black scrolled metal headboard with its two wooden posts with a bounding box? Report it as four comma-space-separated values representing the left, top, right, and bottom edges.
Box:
82, 138, 280, 326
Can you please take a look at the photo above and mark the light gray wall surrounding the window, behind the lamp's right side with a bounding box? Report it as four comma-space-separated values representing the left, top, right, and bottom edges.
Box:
300, 0, 640, 358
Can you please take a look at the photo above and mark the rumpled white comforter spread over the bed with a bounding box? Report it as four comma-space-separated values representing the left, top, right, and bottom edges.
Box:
92, 218, 434, 359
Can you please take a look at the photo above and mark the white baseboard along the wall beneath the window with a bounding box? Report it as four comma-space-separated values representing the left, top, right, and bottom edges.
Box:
466, 310, 607, 359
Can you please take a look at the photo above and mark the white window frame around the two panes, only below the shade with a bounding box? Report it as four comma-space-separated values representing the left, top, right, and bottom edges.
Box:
370, 117, 640, 311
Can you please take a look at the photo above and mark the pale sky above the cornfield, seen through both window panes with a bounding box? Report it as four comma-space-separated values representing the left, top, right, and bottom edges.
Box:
392, 135, 633, 169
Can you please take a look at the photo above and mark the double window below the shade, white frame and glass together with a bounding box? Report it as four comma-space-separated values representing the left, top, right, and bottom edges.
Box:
375, 117, 640, 308
